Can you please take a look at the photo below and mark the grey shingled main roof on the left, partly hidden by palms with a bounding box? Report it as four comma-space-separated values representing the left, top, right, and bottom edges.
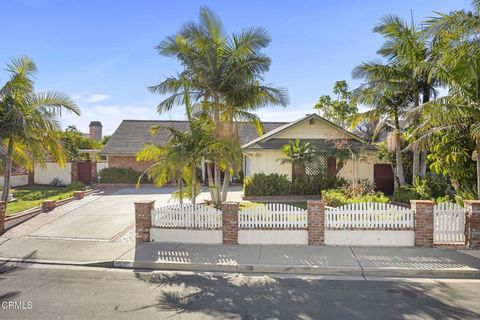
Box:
101, 120, 286, 156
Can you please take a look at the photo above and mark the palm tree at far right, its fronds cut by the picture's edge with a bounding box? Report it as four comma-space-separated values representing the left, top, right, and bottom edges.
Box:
408, 0, 480, 196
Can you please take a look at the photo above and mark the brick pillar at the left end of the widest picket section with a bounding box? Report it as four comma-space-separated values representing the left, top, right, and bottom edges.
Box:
307, 200, 325, 246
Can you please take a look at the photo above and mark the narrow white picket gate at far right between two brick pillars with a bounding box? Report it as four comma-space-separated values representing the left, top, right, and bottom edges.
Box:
433, 202, 465, 244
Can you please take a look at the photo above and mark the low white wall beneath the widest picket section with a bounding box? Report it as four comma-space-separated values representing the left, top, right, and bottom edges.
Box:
325, 230, 415, 247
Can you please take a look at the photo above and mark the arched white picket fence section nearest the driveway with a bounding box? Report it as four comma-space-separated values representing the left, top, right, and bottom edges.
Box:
152, 204, 222, 230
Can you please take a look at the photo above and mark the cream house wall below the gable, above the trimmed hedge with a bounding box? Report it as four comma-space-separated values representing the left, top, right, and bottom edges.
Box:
248, 150, 292, 178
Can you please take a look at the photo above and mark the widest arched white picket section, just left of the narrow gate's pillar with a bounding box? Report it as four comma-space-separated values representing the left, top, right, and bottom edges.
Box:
325, 202, 414, 230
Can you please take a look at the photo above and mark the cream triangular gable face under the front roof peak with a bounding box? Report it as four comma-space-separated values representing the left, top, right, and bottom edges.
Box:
275, 119, 349, 139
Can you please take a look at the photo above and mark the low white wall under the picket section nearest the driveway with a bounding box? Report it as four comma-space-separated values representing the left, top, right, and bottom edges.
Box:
150, 228, 223, 244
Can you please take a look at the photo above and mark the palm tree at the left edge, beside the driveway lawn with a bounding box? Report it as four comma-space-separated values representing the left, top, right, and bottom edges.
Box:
0, 57, 80, 201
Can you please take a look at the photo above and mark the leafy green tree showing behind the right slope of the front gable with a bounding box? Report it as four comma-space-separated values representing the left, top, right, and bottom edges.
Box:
313, 80, 357, 129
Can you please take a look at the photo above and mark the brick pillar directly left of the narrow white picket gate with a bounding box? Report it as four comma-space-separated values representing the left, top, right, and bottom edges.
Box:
410, 200, 434, 247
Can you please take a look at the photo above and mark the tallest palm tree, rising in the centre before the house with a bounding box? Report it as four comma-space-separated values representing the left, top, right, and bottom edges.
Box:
150, 7, 288, 202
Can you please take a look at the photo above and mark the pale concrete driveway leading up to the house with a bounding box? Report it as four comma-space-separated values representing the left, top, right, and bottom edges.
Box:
29, 187, 241, 241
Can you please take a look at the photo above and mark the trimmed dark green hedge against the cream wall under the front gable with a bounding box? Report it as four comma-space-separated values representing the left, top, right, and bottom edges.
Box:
243, 173, 291, 196
